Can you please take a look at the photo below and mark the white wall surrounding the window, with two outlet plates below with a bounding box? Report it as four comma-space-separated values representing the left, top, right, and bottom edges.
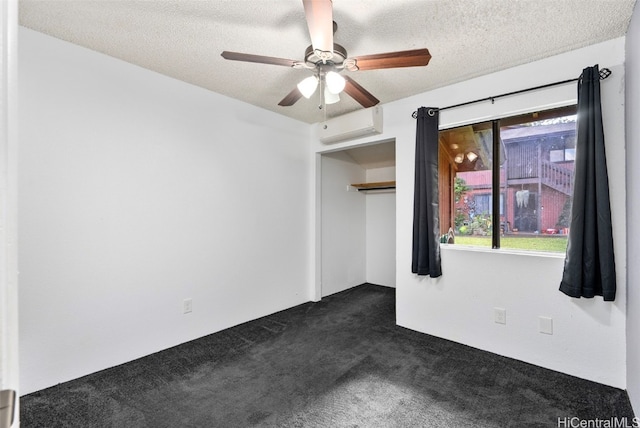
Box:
313, 38, 626, 388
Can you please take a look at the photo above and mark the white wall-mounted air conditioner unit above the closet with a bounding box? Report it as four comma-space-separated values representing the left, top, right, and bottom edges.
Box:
316, 106, 382, 143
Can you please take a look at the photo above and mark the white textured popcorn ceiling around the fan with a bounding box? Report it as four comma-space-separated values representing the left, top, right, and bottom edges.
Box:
19, 0, 635, 123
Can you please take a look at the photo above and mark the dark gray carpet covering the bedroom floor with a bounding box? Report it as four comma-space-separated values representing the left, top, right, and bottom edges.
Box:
21, 284, 633, 428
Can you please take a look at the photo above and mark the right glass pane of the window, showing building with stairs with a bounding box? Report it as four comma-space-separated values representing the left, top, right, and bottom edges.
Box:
500, 115, 576, 252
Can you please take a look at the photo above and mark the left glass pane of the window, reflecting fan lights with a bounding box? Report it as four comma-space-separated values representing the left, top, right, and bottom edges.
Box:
440, 122, 493, 247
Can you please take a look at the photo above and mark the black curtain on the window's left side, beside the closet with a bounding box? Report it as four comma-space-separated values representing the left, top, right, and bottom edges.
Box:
411, 107, 442, 278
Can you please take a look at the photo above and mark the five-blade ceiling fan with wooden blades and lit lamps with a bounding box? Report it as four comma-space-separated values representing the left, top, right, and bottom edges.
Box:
222, 0, 431, 108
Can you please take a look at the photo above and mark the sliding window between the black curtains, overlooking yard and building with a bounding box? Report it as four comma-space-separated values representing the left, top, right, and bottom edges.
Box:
439, 106, 576, 252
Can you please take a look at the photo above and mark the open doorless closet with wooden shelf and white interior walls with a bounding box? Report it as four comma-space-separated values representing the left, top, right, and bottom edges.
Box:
319, 139, 396, 297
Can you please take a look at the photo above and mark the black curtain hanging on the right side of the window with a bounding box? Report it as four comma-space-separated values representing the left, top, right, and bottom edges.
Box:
560, 65, 616, 301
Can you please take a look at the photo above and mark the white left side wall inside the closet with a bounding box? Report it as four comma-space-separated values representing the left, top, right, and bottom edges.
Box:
321, 152, 366, 297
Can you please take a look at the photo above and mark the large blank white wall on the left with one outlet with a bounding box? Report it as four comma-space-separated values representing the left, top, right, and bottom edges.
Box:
19, 28, 312, 394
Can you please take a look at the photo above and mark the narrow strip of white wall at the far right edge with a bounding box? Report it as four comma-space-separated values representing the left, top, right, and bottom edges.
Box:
625, 3, 640, 414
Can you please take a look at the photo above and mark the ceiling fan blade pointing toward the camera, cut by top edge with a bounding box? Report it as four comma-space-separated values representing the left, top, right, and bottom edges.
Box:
302, 0, 333, 59
